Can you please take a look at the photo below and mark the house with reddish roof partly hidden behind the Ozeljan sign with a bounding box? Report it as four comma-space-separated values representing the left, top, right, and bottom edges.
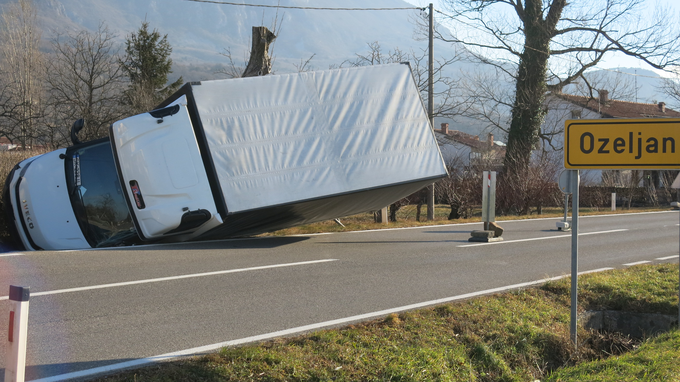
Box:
541, 90, 680, 186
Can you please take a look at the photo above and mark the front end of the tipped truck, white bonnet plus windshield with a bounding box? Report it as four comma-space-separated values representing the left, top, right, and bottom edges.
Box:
3, 139, 138, 250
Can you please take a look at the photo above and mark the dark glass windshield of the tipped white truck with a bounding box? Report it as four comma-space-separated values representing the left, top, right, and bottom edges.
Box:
65, 139, 139, 247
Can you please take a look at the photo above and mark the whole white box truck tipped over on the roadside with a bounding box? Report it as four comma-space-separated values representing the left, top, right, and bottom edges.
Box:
4, 64, 446, 250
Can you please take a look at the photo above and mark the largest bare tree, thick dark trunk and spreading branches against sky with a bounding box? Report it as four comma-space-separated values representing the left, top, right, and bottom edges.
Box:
439, 0, 680, 176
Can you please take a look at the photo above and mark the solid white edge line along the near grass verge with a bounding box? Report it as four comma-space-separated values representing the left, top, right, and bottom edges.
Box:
33, 268, 613, 382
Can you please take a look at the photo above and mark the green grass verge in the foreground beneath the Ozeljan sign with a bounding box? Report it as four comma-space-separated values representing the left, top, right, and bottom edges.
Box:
95, 264, 680, 382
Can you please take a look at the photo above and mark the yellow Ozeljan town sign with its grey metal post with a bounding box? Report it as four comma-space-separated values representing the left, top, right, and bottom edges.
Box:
564, 118, 680, 343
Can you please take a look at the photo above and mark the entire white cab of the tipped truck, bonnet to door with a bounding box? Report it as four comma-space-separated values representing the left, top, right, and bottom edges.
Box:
5, 103, 221, 250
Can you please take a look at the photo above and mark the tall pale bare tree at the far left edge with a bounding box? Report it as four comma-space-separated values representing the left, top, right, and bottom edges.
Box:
0, 0, 44, 148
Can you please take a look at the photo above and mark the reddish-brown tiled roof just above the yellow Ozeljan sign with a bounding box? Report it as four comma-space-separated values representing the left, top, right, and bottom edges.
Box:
553, 93, 680, 118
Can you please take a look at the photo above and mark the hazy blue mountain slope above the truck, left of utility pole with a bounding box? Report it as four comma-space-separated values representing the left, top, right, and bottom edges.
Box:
19, 0, 452, 80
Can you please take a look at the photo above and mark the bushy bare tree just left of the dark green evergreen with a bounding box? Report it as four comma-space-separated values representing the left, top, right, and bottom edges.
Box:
46, 24, 129, 144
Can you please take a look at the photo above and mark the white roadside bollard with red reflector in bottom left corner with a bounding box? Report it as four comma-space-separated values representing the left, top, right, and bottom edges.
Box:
5, 285, 31, 382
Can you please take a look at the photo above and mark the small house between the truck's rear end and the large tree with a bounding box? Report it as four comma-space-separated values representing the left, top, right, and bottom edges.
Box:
434, 123, 505, 171
